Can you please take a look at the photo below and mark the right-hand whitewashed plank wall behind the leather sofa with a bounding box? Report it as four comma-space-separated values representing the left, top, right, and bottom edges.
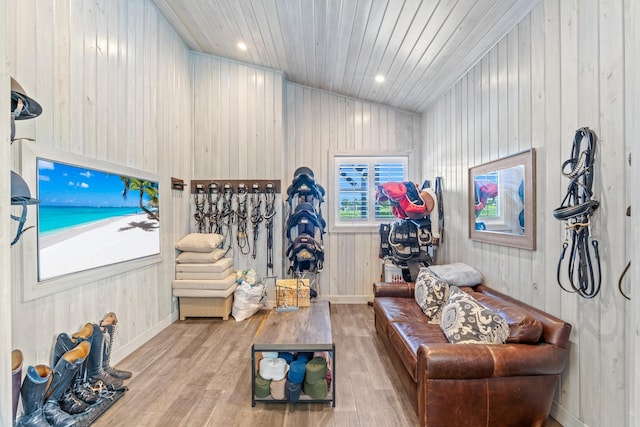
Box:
422, 0, 638, 425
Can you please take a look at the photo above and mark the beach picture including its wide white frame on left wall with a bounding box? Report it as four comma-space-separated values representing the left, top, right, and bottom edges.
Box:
22, 143, 161, 299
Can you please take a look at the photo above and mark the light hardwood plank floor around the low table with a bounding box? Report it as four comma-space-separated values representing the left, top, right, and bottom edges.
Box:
93, 304, 561, 427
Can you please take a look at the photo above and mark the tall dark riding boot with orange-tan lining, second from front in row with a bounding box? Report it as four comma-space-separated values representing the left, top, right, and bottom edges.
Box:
44, 341, 91, 427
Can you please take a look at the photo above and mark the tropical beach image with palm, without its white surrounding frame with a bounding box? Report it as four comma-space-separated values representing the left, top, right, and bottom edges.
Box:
37, 159, 160, 281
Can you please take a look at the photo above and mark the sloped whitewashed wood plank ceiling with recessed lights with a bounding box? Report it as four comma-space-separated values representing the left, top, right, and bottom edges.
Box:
153, 0, 538, 112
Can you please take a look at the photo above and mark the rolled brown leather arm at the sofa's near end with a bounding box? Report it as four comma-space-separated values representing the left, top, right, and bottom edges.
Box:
418, 343, 568, 380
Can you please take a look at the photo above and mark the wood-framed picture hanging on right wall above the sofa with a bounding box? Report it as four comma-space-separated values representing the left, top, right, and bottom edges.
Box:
469, 148, 536, 250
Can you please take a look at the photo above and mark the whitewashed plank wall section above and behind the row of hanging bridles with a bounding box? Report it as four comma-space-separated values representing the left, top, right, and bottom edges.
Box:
189, 53, 286, 294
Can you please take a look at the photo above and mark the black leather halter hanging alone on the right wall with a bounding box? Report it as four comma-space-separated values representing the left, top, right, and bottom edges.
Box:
553, 127, 602, 298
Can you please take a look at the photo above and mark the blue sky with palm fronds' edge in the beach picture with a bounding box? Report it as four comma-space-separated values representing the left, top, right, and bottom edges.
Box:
38, 159, 156, 207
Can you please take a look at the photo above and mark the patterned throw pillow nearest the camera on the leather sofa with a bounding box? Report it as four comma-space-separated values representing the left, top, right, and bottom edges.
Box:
440, 286, 509, 344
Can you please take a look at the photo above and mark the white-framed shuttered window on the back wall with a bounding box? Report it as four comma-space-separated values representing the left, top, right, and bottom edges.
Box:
333, 156, 408, 228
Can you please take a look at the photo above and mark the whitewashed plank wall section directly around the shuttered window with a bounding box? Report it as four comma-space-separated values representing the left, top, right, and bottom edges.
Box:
283, 83, 422, 302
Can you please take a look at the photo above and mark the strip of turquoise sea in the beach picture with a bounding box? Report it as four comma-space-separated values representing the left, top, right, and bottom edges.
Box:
38, 206, 142, 234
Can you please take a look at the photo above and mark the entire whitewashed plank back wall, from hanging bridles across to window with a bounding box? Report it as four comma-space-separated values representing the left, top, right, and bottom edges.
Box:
190, 57, 421, 302
